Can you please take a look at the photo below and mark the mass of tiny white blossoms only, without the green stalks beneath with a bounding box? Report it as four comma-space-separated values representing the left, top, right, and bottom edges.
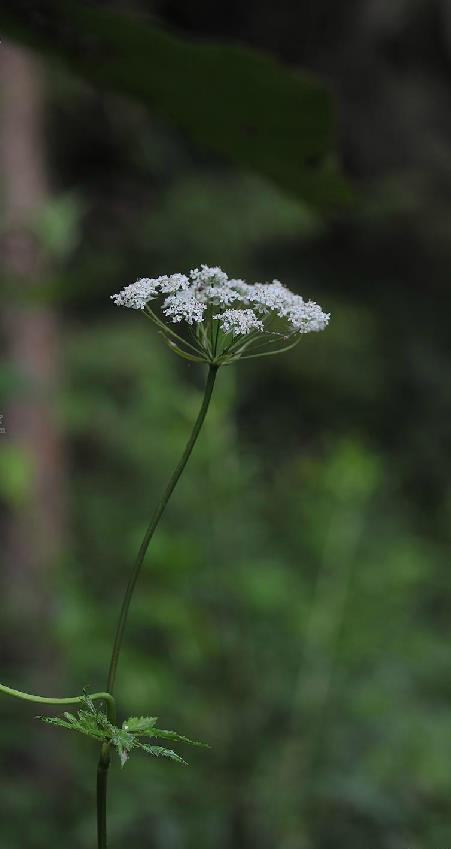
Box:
112, 265, 330, 336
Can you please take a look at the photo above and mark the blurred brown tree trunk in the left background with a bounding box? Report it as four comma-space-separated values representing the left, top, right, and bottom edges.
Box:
0, 44, 62, 668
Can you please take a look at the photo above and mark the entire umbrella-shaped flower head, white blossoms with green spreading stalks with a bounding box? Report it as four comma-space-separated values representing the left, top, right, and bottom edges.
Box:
111, 265, 330, 365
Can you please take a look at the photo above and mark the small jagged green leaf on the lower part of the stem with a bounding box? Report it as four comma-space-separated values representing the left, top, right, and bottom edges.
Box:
37, 695, 205, 766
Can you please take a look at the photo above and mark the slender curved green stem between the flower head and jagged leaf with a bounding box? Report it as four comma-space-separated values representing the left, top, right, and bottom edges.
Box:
107, 364, 218, 693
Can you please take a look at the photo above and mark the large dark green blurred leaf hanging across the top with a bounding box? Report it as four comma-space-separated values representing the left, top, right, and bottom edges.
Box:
0, 0, 351, 207
